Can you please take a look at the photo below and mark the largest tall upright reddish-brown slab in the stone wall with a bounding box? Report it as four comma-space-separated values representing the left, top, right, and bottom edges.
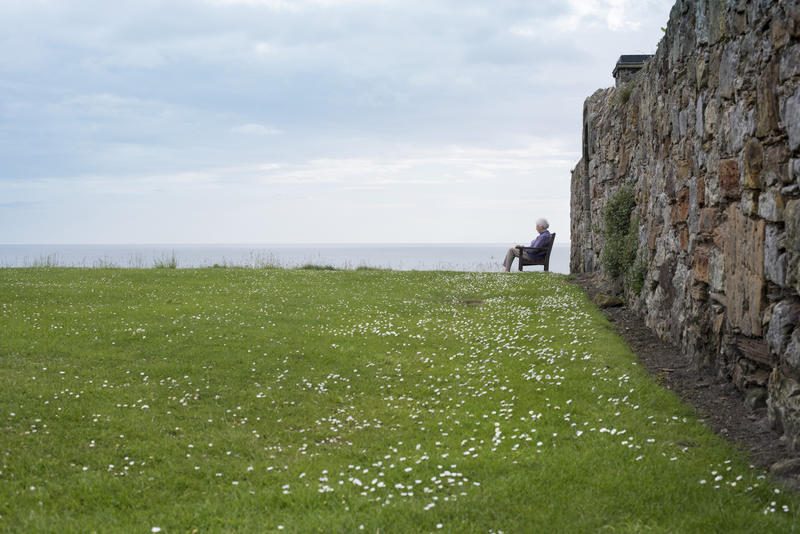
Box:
725, 204, 765, 336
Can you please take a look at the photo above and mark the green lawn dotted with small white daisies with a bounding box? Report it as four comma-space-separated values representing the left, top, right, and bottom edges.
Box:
0, 268, 800, 533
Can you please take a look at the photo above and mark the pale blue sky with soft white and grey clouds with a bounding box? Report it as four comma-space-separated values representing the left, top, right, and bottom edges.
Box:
0, 0, 673, 244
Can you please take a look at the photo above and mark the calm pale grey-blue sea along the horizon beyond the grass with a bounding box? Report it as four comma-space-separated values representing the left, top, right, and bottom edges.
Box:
0, 243, 569, 274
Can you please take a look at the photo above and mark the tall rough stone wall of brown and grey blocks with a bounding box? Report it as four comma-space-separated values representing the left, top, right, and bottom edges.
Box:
570, 0, 800, 448
